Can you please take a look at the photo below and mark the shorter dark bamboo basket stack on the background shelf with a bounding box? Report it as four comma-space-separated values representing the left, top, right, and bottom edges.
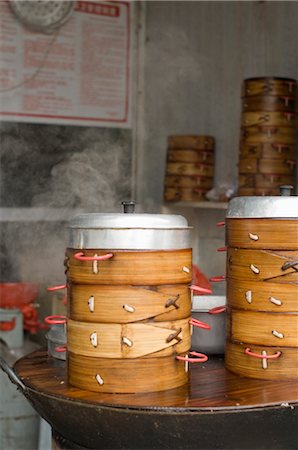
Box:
164, 135, 215, 201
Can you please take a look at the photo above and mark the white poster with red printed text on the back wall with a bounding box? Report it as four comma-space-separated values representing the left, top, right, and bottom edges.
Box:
0, 1, 131, 128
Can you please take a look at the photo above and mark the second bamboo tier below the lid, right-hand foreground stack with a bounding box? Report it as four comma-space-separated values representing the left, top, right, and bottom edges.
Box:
227, 248, 298, 283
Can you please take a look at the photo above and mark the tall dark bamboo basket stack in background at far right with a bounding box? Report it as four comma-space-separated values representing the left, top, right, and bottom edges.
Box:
238, 77, 297, 196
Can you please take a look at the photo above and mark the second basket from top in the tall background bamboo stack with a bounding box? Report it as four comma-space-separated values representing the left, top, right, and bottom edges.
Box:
242, 95, 296, 113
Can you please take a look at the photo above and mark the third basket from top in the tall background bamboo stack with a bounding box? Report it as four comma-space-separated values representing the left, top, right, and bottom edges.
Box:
241, 111, 296, 127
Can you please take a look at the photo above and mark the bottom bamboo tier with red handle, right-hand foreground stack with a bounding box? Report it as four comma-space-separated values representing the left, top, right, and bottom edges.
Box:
225, 341, 298, 380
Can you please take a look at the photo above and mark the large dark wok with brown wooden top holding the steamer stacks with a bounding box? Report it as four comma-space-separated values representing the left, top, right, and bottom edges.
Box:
14, 350, 298, 450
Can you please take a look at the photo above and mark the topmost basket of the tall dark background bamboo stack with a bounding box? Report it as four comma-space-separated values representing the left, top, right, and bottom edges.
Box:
242, 77, 297, 97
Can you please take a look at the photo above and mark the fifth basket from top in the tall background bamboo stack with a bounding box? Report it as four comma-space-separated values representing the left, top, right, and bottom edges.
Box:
240, 142, 296, 159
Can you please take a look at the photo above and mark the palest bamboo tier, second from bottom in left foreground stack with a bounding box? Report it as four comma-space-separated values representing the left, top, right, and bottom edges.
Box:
67, 317, 190, 358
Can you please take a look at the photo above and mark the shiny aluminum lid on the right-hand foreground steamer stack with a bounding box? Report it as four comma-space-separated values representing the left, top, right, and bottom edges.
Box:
226, 196, 298, 219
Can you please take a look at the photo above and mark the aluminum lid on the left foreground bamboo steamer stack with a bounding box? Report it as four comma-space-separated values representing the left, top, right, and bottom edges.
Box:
68, 213, 191, 250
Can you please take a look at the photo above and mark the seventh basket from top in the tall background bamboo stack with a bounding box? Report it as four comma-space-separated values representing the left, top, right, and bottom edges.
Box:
238, 173, 296, 189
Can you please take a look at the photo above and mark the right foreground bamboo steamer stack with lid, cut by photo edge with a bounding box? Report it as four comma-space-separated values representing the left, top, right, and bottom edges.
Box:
225, 186, 298, 380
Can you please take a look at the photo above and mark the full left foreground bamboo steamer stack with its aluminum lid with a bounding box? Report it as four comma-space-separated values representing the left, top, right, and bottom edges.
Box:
66, 203, 198, 393
